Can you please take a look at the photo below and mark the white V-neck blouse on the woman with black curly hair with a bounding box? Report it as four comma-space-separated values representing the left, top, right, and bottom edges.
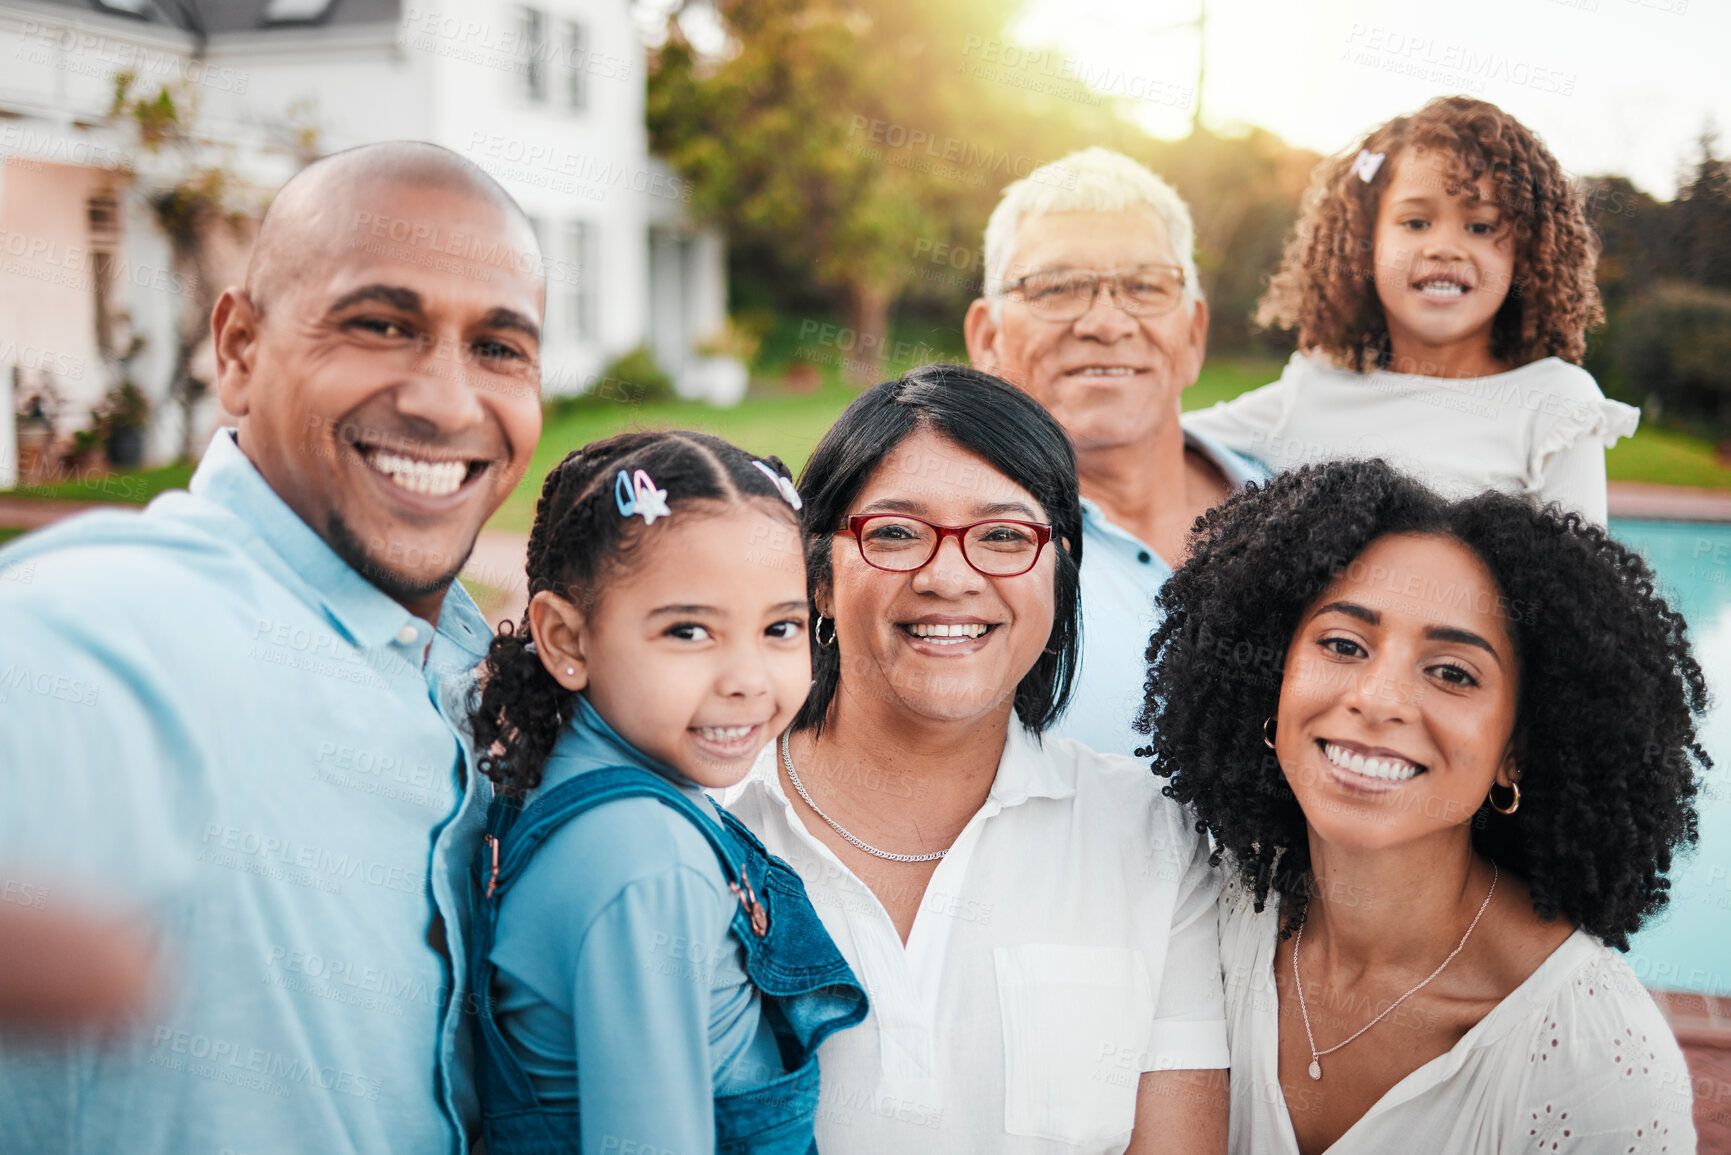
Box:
1220, 880, 1695, 1155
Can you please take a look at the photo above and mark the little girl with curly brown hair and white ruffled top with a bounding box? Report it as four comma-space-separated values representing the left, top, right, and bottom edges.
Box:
1186, 97, 1639, 525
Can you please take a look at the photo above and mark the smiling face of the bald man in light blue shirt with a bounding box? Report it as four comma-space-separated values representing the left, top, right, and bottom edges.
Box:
213, 180, 542, 620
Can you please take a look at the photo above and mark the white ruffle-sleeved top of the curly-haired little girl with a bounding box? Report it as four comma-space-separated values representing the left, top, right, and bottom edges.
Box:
1184, 353, 1641, 525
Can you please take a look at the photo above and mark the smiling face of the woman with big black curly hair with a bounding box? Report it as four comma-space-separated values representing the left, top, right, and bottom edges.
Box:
1276, 533, 1518, 850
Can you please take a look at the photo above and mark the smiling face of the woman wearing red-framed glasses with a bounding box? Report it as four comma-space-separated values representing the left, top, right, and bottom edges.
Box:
819, 429, 1059, 722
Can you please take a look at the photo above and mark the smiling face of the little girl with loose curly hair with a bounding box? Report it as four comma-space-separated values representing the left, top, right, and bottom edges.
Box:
1374, 151, 1515, 377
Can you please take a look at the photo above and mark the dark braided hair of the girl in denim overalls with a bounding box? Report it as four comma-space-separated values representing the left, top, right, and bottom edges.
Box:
469, 429, 798, 797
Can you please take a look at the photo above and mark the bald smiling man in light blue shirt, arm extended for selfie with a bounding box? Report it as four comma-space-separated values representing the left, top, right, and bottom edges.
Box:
0, 144, 544, 1155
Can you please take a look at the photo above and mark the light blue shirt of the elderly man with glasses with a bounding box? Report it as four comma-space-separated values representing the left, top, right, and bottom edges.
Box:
1047, 429, 1269, 755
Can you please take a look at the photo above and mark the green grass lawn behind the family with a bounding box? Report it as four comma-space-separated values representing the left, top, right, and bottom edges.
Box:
0, 353, 1731, 540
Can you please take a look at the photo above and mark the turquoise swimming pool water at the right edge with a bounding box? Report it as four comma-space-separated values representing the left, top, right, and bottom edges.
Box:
1610, 521, 1731, 996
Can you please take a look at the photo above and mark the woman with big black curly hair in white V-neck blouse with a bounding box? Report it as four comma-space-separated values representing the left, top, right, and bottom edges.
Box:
1141, 461, 1710, 1155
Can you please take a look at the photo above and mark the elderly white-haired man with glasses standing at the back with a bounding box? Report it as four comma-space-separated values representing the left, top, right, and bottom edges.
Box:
964, 149, 1267, 753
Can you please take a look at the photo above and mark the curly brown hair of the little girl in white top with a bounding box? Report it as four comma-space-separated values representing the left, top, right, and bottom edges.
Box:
1257, 97, 1605, 372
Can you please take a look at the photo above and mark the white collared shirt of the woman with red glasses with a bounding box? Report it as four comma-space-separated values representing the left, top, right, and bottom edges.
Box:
729, 722, 1227, 1155
